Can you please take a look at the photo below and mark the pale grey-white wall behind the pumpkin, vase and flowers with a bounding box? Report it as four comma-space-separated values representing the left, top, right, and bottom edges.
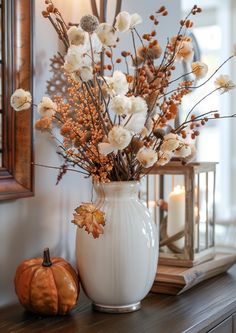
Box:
0, 0, 180, 305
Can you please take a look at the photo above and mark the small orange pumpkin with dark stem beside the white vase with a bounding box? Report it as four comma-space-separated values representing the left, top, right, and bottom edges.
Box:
15, 248, 79, 315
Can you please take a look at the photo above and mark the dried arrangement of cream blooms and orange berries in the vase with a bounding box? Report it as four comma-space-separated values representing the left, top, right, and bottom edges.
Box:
11, 0, 235, 237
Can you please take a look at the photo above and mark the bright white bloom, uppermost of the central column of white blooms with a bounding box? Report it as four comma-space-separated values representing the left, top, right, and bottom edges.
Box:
105, 71, 129, 96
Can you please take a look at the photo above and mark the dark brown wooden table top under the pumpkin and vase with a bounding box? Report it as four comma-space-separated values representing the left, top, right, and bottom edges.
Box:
0, 265, 236, 333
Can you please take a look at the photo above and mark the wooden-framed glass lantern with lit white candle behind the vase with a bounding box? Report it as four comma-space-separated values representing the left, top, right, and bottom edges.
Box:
141, 162, 216, 267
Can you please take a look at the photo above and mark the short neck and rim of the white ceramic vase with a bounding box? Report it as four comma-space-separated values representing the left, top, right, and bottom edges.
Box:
94, 181, 140, 200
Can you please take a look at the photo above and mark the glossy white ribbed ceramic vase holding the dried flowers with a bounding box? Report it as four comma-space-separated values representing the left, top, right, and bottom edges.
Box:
76, 181, 159, 312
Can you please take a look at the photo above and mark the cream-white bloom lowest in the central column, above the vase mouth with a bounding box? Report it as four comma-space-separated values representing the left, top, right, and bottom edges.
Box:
98, 126, 132, 155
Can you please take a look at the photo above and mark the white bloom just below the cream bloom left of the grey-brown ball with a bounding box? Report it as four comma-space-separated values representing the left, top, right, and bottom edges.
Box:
64, 45, 91, 73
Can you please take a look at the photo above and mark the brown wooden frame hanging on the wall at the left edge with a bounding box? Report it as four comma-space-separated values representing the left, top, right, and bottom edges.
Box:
0, 0, 34, 200
